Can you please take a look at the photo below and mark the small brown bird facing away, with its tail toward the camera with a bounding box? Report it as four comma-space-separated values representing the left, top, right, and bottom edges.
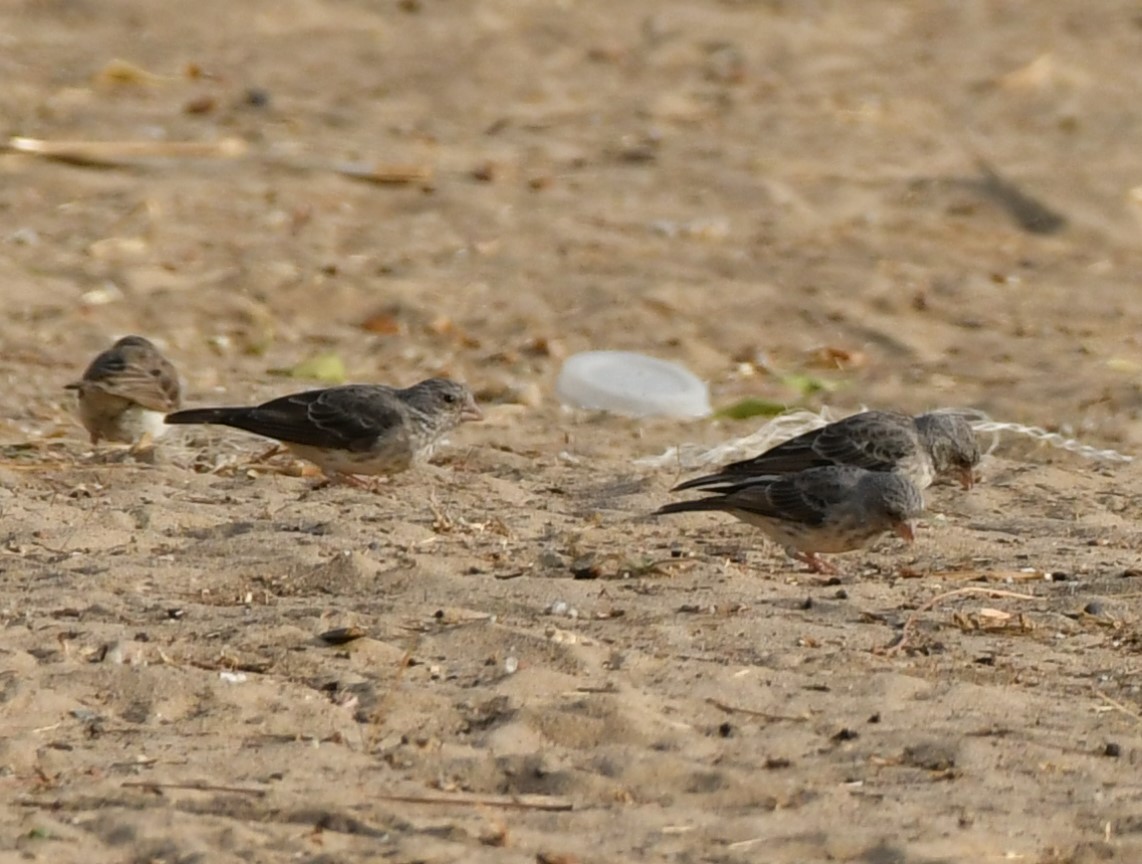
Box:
65, 336, 182, 447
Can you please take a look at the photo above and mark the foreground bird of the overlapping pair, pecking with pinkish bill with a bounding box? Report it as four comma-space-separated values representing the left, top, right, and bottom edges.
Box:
654, 465, 924, 573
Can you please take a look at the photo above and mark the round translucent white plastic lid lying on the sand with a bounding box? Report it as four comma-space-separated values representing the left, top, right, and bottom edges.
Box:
555, 352, 711, 417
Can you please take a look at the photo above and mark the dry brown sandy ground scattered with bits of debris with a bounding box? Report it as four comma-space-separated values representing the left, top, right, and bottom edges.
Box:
0, 0, 1142, 864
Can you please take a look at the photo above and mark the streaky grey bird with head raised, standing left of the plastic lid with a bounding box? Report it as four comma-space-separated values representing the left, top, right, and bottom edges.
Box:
167, 378, 483, 486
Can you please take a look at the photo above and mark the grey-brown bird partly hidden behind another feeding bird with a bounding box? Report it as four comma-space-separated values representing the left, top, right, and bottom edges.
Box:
674, 411, 980, 491
